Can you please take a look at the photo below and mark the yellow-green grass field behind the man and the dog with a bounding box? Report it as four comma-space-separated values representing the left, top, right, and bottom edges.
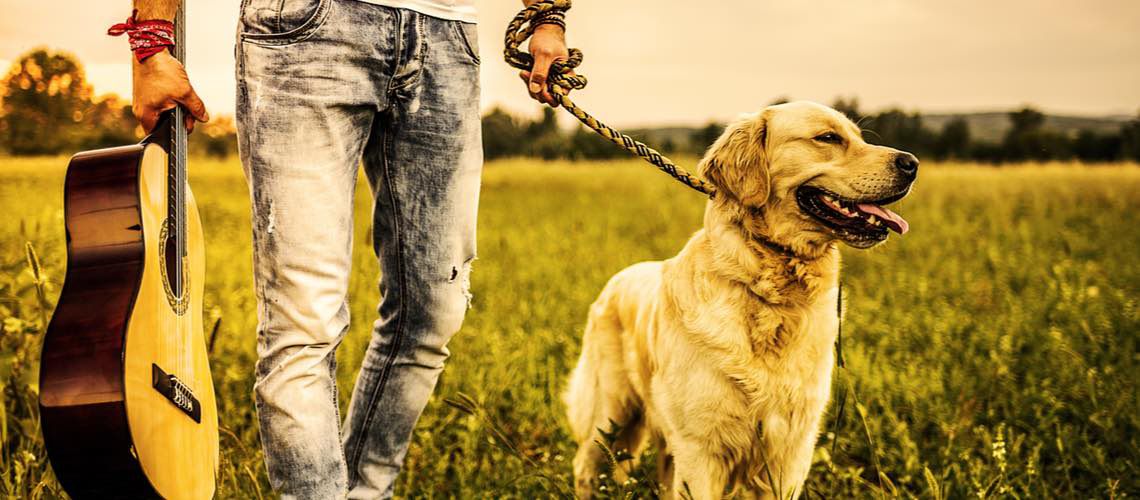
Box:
0, 158, 1140, 499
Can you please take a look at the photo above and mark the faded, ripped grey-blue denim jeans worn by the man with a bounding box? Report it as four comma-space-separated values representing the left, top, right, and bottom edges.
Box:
233, 0, 482, 499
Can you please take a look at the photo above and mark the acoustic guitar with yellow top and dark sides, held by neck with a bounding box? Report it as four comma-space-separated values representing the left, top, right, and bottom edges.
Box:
40, 2, 218, 499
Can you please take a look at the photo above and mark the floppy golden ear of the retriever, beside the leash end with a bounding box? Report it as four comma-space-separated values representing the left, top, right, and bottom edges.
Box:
698, 113, 772, 207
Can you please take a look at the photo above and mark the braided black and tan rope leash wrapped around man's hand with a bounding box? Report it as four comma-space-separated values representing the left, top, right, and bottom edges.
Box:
503, 0, 716, 197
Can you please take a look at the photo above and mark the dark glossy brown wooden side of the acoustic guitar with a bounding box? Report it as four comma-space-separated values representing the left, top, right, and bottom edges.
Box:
40, 145, 160, 498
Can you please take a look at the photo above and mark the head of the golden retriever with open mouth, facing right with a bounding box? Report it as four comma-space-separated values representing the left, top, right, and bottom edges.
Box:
699, 101, 919, 252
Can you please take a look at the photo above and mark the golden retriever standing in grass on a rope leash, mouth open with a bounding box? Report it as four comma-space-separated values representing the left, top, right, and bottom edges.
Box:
565, 103, 919, 500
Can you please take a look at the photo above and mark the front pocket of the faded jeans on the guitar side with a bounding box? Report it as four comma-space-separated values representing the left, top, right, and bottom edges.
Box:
241, 0, 333, 46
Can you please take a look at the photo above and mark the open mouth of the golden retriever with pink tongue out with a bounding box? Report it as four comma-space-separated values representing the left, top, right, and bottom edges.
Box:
796, 186, 910, 248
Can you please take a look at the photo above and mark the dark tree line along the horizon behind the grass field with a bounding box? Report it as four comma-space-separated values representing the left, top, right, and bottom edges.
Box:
0, 49, 1140, 164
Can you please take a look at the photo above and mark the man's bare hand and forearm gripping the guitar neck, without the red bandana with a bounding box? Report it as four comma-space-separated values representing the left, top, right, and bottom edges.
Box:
131, 0, 210, 132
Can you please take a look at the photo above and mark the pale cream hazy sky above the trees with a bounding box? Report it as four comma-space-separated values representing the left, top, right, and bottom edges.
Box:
0, 0, 1140, 126
